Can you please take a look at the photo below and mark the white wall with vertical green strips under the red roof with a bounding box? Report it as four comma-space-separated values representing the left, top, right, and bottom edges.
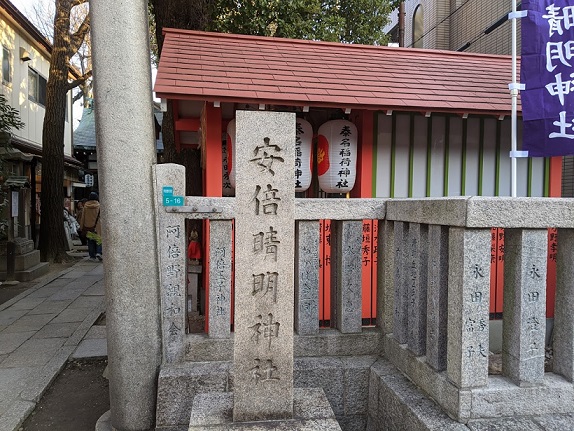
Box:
375, 112, 545, 198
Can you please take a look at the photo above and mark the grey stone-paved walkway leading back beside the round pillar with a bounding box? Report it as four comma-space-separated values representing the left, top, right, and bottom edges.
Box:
0, 259, 107, 431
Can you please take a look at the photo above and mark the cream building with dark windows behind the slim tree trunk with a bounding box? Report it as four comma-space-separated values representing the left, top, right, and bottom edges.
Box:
0, 0, 81, 243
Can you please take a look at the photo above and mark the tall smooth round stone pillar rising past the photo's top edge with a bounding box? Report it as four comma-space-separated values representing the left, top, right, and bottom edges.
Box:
90, 0, 161, 431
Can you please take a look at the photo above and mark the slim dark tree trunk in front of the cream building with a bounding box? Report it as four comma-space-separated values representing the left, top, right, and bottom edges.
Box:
40, 0, 91, 262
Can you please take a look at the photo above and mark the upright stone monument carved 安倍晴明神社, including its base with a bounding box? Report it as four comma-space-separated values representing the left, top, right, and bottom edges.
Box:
189, 111, 340, 431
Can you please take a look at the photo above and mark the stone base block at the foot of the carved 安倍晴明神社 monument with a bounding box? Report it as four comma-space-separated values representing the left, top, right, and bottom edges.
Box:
189, 388, 341, 431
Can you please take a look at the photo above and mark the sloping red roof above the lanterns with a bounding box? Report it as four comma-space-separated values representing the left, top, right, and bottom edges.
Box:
154, 29, 511, 115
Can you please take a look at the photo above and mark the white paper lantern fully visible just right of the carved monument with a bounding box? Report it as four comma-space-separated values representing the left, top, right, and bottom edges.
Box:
317, 120, 357, 193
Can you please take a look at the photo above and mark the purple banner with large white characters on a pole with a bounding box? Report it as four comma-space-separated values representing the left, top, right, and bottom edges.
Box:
520, 0, 574, 157
